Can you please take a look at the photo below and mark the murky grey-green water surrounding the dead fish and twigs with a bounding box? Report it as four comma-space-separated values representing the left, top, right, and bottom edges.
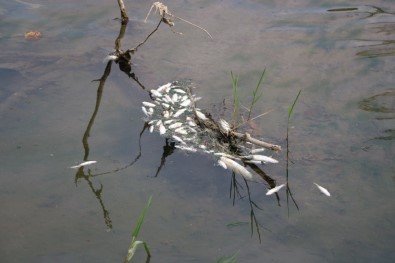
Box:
0, 0, 395, 262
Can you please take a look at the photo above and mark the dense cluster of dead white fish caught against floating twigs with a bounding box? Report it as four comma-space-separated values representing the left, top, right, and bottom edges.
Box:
142, 81, 284, 183
